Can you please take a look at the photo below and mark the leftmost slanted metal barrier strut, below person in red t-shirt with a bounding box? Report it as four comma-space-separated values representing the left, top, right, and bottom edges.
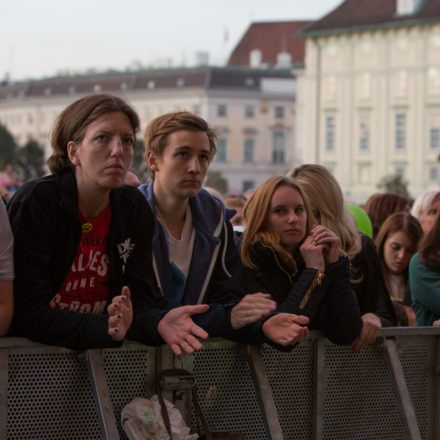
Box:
86, 349, 119, 440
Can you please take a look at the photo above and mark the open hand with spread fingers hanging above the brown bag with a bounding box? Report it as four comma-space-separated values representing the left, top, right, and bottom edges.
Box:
157, 304, 209, 356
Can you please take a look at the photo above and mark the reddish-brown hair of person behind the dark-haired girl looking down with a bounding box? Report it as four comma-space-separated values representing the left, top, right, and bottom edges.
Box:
365, 193, 410, 240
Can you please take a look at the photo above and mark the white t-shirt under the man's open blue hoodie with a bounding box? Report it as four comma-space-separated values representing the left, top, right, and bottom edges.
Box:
157, 206, 196, 303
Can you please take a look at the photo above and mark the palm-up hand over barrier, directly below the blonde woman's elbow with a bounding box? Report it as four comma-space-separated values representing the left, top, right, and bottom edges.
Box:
262, 313, 309, 346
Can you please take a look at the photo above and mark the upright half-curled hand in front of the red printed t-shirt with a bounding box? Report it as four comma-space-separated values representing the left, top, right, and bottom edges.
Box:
107, 286, 133, 341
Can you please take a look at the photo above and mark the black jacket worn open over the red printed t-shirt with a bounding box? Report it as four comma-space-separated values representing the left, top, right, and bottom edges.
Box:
8, 171, 168, 349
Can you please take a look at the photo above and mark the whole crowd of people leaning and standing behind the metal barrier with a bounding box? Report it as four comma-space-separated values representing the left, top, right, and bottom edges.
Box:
0, 94, 440, 355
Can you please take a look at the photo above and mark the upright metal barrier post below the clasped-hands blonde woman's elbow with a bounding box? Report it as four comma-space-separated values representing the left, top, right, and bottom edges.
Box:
312, 339, 326, 440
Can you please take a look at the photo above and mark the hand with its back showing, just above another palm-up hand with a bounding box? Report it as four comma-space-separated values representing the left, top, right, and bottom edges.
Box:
231, 292, 277, 330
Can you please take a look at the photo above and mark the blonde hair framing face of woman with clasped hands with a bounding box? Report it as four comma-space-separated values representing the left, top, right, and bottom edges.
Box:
240, 176, 314, 270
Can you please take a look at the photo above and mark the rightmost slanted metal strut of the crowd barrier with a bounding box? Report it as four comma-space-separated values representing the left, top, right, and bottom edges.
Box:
384, 338, 422, 440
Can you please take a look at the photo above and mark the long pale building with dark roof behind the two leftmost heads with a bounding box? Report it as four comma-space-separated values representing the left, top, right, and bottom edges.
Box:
0, 67, 298, 192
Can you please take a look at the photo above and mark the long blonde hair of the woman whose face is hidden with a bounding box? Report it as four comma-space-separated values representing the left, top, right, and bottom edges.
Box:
288, 164, 361, 259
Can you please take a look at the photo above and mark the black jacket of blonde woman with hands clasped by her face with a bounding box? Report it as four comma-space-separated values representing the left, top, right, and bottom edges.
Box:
243, 243, 362, 344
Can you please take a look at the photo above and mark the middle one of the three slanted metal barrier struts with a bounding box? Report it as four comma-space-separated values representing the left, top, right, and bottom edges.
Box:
248, 345, 284, 440
